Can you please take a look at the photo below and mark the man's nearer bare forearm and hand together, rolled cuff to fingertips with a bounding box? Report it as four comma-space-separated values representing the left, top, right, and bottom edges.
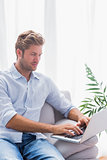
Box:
6, 114, 81, 135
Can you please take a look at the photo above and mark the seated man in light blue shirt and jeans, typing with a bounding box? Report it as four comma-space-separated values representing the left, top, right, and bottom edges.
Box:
0, 30, 97, 160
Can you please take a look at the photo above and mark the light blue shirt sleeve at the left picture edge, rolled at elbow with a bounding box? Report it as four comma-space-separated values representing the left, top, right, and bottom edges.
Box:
0, 78, 17, 126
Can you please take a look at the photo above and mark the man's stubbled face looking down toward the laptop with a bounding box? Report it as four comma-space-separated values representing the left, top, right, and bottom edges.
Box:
18, 45, 42, 71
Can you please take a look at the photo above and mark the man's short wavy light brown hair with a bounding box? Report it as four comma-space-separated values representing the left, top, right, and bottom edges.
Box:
15, 30, 45, 54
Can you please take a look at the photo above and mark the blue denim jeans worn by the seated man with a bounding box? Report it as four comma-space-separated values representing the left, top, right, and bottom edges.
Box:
0, 133, 64, 160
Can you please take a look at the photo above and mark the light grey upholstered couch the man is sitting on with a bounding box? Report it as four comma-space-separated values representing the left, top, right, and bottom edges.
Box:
40, 91, 98, 160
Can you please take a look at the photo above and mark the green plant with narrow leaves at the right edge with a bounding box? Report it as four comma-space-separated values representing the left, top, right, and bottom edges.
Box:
79, 64, 107, 117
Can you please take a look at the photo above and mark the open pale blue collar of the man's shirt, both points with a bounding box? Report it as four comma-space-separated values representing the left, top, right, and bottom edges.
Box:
10, 64, 39, 79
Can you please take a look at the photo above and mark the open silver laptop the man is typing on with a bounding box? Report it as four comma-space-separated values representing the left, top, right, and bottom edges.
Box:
51, 108, 107, 143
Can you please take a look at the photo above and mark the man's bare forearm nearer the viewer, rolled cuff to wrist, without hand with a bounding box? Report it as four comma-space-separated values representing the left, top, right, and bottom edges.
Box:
6, 114, 53, 133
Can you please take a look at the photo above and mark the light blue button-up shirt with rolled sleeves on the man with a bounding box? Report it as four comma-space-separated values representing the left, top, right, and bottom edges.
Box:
0, 64, 74, 143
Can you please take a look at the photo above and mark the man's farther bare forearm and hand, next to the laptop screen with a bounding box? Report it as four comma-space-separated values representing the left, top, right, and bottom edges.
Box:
68, 108, 90, 126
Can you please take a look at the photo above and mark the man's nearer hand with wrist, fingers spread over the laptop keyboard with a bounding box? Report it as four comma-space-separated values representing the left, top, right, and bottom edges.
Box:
53, 124, 83, 136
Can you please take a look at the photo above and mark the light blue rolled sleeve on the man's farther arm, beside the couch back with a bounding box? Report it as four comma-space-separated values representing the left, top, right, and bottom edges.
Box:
46, 79, 75, 117
